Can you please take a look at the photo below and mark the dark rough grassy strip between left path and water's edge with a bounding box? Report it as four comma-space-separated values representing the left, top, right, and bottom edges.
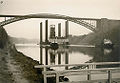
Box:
8, 46, 43, 83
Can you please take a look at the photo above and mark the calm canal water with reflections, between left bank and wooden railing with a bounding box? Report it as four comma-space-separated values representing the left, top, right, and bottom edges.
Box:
16, 44, 120, 81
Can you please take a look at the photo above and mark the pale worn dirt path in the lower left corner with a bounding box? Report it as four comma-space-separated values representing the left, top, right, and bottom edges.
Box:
0, 50, 29, 83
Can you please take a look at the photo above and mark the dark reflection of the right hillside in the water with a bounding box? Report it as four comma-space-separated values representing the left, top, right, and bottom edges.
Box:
70, 47, 120, 62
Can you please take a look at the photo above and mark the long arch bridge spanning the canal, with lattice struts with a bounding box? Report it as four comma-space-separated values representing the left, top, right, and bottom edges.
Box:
0, 13, 101, 32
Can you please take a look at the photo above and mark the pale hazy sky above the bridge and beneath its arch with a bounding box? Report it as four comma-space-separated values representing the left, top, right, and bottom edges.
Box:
0, 0, 120, 39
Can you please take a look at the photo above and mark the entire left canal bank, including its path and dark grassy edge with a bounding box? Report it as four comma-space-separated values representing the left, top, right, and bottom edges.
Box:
0, 43, 44, 83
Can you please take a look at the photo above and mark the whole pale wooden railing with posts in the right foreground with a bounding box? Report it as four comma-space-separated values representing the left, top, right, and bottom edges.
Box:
35, 62, 120, 83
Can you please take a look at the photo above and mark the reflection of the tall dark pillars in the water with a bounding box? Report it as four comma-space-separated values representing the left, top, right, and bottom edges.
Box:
40, 47, 69, 69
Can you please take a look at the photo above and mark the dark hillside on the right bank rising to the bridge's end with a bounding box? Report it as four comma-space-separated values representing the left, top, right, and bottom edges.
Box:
69, 20, 120, 45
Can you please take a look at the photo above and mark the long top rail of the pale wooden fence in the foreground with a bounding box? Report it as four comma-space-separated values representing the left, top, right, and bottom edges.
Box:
34, 62, 120, 68
